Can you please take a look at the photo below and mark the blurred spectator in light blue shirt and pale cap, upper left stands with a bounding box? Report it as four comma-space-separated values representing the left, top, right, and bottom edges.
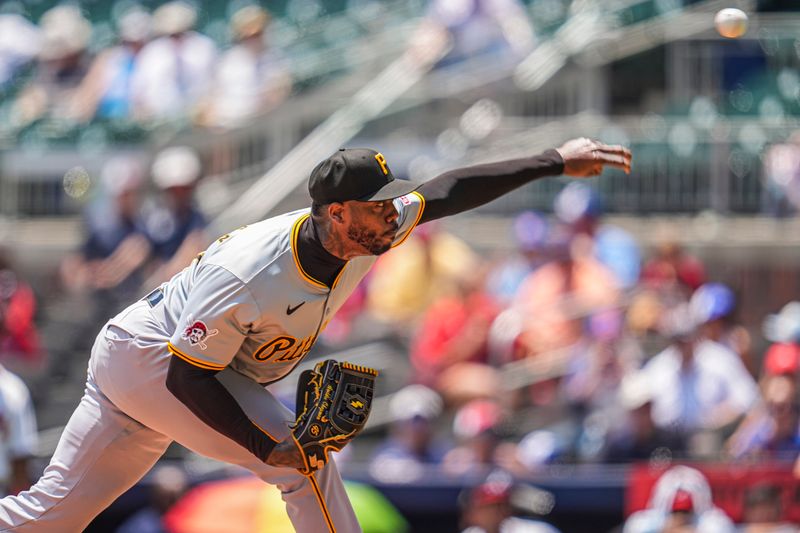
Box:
70, 6, 152, 121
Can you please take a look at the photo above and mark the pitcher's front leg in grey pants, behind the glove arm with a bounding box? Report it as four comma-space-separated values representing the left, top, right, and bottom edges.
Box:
101, 350, 360, 533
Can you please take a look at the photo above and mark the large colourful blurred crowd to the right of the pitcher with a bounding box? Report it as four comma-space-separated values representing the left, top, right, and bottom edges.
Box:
340, 182, 800, 475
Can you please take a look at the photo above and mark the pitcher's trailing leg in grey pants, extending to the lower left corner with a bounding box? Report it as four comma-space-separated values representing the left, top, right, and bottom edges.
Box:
0, 377, 170, 533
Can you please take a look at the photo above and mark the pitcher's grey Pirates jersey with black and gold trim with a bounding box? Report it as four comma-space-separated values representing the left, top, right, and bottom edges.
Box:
119, 193, 425, 384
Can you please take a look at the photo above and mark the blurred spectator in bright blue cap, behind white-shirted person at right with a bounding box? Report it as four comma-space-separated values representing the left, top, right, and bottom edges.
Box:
689, 283, 758, 376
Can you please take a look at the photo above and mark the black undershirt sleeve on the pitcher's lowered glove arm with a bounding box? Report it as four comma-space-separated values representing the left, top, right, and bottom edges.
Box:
167, 357, 276, 461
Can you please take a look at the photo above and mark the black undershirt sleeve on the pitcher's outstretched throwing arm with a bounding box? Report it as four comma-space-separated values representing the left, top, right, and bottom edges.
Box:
417, 150, 564, 224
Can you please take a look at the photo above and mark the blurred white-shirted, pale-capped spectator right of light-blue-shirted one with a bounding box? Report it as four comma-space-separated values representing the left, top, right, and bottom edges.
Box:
131, 0, 217, 120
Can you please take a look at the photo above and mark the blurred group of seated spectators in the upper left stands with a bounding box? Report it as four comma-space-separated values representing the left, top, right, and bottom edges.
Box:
0, 0, 292, 132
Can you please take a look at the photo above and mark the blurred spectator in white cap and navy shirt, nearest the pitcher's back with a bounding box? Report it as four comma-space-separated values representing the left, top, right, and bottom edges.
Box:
145, 146, 208, 287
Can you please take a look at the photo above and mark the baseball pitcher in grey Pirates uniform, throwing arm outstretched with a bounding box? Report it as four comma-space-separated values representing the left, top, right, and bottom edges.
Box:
0, 139, 631, 533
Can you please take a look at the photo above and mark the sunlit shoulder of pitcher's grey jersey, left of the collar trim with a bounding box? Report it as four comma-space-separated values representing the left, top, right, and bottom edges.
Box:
203, 209, 309, 283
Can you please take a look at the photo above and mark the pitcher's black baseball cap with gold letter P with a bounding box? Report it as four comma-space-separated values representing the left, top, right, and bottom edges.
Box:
308, 148, 422, 204
